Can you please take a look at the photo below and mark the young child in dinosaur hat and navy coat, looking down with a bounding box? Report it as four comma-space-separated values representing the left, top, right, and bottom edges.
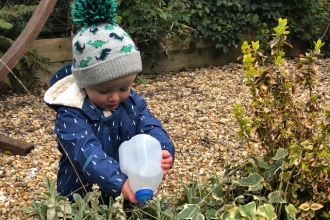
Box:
44, 0, 174, 204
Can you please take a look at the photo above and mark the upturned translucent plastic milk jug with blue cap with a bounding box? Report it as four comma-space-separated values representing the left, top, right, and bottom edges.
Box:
119, 134, 163, 202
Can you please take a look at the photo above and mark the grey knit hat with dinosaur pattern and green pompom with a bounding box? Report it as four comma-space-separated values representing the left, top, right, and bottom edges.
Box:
71, 0, 142, 88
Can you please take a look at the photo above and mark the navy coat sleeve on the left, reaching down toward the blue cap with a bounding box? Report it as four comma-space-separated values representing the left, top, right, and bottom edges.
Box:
55, 108, 127, 197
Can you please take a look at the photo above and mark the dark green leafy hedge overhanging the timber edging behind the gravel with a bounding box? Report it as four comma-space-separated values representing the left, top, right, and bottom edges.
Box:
118, 0, 330, 60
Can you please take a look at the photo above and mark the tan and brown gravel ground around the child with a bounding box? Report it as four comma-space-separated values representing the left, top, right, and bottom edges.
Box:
0, 59, 330, 220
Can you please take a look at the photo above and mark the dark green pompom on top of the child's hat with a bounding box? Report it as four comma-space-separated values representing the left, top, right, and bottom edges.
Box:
71, 0, 118, 27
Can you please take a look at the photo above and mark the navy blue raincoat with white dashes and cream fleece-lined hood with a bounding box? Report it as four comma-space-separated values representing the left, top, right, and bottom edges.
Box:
44, 63, 174, 203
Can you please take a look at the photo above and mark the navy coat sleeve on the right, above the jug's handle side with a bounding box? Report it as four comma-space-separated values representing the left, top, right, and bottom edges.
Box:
134, 94, 175, 160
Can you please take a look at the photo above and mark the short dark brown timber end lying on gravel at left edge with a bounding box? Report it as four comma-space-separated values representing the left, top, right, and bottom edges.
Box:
0, 134, 34, 156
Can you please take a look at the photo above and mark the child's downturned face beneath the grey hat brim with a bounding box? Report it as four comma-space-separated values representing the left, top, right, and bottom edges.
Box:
85, 74, 136, 111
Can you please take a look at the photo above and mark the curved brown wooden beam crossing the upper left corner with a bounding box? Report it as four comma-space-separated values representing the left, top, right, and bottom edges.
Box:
0, 0, 57, 81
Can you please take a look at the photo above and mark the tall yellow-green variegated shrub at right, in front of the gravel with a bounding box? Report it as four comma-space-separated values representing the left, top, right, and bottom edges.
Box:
234, 19, 330, 219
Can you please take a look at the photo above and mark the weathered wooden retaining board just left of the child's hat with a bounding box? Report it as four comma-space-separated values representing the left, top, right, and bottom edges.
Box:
31, 37, 72, 63
